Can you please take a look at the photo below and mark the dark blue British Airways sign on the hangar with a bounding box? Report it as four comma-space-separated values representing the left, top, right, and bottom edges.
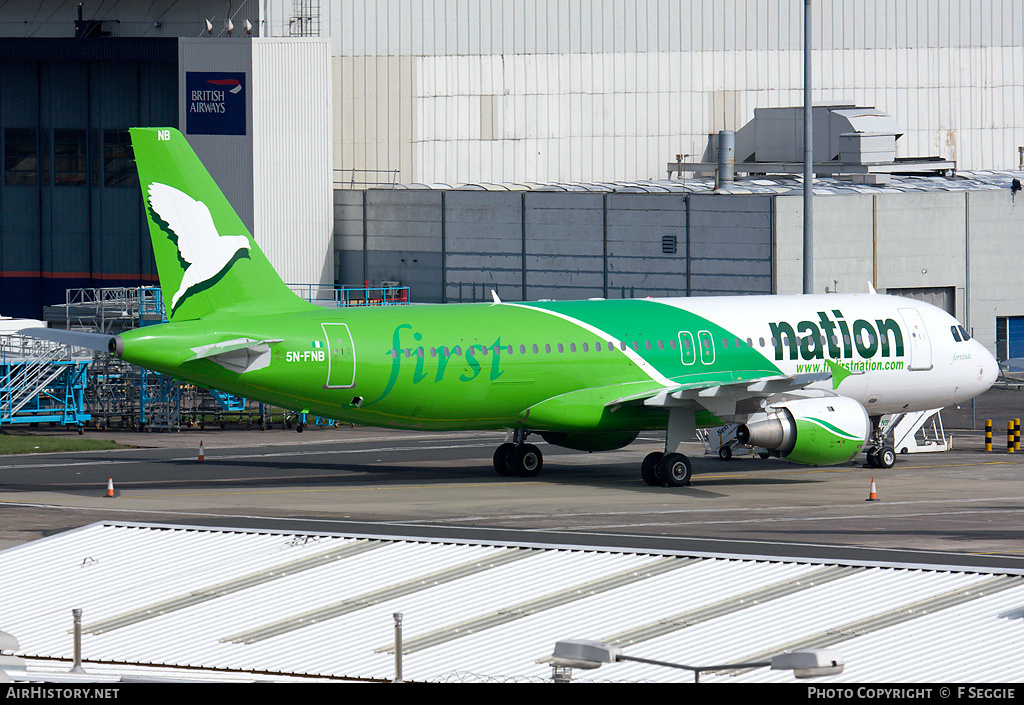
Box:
185, 71, 246, 134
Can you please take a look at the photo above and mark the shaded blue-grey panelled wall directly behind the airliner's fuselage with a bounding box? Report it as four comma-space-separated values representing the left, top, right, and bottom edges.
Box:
335, 190, 773, 301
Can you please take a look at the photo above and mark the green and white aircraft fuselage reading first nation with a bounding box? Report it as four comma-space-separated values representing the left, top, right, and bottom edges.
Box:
117, 294, 996, 431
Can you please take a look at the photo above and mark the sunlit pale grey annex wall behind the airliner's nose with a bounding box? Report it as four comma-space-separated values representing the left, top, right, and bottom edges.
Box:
774, 189, 1024, 351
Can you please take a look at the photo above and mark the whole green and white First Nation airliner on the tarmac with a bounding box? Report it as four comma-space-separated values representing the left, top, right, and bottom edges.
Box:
24, 128, 997, 487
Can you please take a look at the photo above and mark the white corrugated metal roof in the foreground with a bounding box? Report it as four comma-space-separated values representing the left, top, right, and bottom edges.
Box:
0, 523, 1024, 682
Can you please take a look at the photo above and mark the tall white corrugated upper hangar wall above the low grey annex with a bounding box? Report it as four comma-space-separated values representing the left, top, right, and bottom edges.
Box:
324, 0, 1024, 184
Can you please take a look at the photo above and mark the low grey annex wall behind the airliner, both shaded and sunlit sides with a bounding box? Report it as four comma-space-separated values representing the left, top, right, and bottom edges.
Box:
335, 181, 1024, 358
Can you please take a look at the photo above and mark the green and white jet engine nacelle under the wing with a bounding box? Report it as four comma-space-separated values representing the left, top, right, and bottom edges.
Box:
736, 395, 871, 465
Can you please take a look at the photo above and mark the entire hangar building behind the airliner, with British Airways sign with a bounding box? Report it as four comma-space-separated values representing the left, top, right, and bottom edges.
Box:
0, 0, 1024, 351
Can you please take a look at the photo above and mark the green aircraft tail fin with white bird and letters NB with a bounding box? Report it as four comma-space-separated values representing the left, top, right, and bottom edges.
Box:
131, 127, 313, 321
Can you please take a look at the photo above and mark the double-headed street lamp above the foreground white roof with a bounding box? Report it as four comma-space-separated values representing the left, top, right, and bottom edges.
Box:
551, 639, 846, 682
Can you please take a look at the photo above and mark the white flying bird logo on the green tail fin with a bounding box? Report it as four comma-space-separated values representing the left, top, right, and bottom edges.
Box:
150, 182, 249, 309
